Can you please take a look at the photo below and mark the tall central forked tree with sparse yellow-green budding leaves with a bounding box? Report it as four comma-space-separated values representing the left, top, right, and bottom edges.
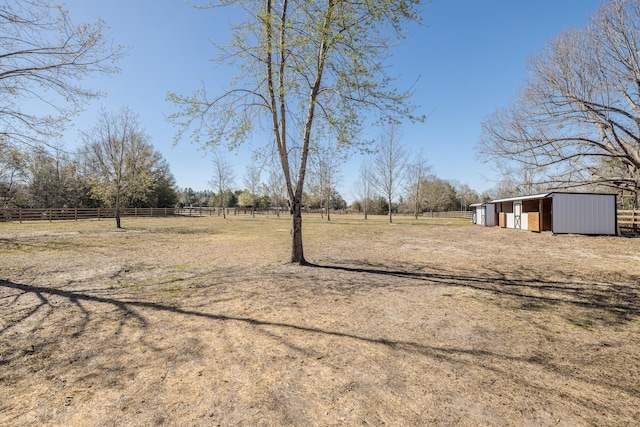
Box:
169, 0, 420, 264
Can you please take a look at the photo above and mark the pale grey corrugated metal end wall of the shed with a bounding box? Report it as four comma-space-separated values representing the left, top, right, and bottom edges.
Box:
551, 193, 616, 234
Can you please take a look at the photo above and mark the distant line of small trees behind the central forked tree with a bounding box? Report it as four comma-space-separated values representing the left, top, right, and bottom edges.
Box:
172, 125, 482, 221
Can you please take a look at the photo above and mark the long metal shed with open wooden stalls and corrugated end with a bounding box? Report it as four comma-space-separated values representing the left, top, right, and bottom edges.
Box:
478, 192, 618, 235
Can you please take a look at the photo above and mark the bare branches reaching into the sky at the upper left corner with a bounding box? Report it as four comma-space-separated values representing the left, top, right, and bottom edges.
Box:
0, 0, 124, 147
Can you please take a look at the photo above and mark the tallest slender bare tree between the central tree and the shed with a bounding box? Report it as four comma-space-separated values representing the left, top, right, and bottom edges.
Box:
373, 122, 407, 223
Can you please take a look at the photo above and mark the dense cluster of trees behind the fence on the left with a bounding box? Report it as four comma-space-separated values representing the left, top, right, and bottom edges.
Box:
0, 108, 178, 222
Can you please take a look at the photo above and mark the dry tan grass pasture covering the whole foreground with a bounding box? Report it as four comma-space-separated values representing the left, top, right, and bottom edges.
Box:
0, 215, 640, 426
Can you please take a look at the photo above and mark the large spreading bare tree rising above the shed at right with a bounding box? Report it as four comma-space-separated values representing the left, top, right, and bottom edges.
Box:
480, 0, 640, 206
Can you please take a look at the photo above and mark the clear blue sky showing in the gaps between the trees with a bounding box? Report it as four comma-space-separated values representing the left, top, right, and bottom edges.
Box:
57, 0, 602, 201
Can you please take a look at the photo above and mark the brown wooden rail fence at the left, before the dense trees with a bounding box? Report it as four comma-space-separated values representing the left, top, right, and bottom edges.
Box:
0, 208, 178, 222
